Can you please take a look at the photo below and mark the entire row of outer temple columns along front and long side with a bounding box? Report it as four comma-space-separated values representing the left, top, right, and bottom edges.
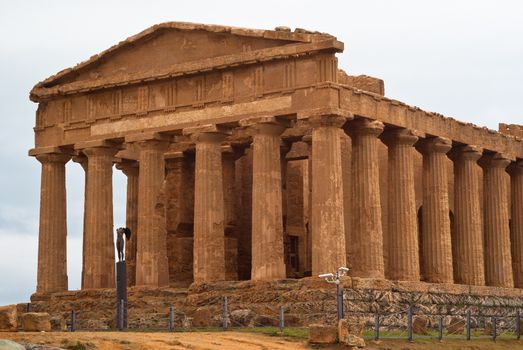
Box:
37, 115, 523, 291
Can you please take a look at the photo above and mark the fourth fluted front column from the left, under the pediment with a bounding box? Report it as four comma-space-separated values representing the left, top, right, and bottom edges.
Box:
193, 133, 225, 282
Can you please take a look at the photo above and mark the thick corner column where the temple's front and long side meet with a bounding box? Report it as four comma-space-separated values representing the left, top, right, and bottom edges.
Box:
309, 115, 347, 276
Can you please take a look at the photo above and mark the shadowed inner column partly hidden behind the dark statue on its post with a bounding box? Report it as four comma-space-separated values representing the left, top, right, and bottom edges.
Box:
116, 160, 139, 286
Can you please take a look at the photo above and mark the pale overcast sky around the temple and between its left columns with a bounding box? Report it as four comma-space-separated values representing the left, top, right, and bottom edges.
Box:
0, 0, 523, 305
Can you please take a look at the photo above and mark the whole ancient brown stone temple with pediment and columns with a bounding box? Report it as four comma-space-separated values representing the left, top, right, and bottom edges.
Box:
29, 22, 523, 294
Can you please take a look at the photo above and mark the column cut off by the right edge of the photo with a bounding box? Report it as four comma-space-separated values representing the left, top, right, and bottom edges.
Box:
509, 160, 523, 288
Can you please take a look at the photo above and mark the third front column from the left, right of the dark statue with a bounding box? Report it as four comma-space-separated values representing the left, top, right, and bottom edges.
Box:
136, 140, 169, 287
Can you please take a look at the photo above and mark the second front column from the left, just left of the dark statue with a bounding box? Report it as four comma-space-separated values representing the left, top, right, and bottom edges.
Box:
82, 147, 117, 289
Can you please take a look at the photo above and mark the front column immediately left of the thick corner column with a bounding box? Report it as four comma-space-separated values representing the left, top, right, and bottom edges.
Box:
251, 124, 285, 280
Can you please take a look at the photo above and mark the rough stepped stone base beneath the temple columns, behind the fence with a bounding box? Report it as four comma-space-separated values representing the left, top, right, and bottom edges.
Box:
27, 277, 523, 330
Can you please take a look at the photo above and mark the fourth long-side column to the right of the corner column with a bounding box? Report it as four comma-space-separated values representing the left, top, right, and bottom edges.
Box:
449, 145, 485, 286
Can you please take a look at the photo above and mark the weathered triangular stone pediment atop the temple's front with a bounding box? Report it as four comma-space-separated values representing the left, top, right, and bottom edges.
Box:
33, 22, 340, 100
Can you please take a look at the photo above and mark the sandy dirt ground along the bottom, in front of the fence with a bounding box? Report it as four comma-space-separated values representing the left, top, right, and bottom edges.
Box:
0, 332, 523, 350
